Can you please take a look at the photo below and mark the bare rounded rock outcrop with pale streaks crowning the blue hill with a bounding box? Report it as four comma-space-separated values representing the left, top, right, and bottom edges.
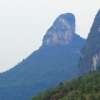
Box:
43, 13, 75, 46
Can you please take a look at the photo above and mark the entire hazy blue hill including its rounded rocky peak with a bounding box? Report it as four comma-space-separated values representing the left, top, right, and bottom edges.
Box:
0, 13, 85, 100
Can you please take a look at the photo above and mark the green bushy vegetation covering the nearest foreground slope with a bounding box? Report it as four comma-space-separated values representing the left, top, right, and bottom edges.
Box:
32, 71, 100, 100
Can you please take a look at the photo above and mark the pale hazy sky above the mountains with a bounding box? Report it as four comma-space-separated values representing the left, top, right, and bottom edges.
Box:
0, 0, 100, 72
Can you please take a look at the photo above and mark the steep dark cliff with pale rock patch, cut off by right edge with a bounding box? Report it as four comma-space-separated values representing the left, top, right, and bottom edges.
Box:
78, 10, 100, 75
